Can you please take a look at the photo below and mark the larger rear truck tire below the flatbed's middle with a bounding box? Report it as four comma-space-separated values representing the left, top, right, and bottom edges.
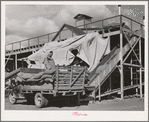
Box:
34, 93, 48, 108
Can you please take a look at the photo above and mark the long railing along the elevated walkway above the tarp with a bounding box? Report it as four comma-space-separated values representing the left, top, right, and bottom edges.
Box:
5, 15, 144, 53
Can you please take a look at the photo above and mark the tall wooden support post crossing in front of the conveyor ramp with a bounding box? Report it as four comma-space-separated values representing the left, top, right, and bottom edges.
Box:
120, 15, 124, 99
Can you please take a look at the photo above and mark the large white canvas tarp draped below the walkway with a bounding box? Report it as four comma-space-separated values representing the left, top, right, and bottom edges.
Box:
28, 32, 110, 71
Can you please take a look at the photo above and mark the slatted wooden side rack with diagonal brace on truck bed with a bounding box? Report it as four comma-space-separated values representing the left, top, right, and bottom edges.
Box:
55, 66, 86, 90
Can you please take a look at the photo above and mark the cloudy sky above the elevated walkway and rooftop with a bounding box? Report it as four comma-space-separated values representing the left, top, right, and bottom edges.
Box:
5, 4, 145, 44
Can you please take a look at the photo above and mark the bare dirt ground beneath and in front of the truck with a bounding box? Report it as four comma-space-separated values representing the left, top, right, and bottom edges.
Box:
5, 96, 144, 111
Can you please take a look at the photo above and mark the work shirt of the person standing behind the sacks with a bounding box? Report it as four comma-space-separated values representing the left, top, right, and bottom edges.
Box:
44, 58, 55, 70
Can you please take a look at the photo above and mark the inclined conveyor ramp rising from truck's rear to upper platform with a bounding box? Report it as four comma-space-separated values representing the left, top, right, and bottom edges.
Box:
86, 35, 138, 96
